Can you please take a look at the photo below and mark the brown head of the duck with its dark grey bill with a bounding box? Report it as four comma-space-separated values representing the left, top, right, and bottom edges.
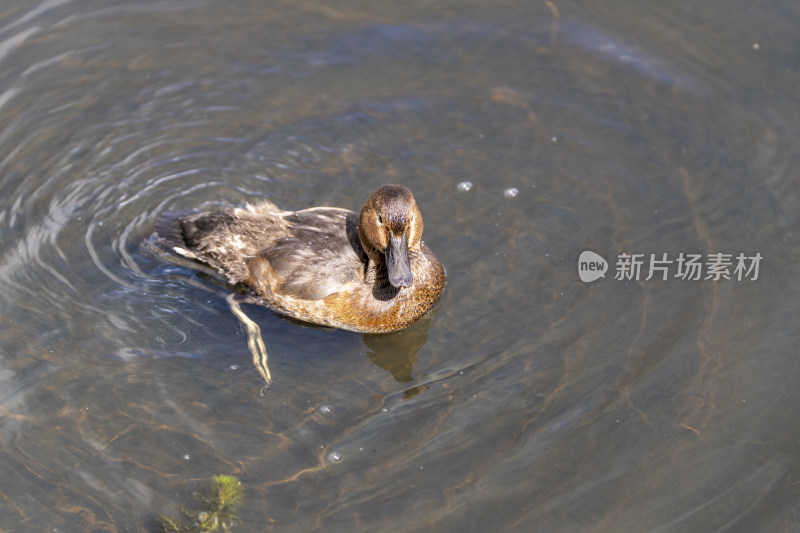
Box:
358, 185, 422, 289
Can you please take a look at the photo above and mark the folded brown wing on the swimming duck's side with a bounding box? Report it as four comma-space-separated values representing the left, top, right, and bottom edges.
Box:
251, 207, 367, 300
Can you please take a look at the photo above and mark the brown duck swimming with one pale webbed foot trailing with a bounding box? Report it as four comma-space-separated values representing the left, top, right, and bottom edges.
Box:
156, 185, 445, 385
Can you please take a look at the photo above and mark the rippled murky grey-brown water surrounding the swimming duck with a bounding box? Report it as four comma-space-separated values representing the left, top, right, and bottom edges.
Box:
0, 0, 800, 532
